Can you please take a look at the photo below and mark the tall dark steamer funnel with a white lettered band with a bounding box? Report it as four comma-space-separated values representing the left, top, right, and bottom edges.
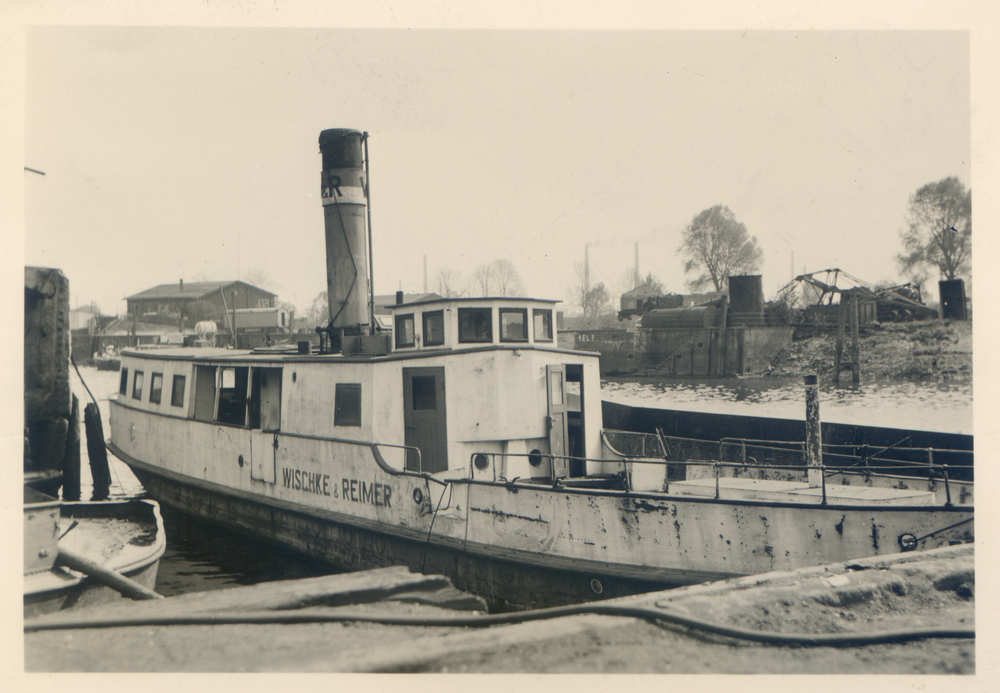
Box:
319, 129, 368, 334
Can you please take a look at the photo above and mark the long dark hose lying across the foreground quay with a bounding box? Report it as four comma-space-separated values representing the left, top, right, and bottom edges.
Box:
24, 603, 976, 647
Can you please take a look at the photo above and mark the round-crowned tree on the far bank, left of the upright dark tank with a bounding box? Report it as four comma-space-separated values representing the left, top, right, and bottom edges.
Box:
678, 205, 764, 291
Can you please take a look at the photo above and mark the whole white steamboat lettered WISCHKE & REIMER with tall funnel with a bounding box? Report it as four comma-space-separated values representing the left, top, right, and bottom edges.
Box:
108, 129, 974, 609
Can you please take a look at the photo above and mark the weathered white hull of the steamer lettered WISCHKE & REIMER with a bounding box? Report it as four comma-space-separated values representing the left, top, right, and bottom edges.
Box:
112, 403, 973, 606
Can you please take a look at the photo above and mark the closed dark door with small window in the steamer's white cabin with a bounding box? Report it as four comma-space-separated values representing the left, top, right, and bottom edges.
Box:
403, 368, 448, 472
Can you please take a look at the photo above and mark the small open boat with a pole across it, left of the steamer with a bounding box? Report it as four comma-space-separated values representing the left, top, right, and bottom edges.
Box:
24, 486, 166, 618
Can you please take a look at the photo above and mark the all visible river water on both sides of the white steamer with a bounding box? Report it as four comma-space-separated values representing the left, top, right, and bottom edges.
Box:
70, 367, 972, 596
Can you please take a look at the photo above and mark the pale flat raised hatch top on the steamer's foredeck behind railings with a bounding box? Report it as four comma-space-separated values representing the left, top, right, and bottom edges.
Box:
667, 477, 936, 505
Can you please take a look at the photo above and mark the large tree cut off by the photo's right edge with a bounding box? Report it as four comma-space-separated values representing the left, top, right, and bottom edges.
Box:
896, 176, 972, 284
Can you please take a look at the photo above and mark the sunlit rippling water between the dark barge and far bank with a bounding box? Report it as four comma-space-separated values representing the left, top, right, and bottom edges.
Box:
601, 377, 973, 434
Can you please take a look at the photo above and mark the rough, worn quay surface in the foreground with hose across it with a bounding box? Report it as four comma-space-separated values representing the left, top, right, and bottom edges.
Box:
24, 545, 975, 675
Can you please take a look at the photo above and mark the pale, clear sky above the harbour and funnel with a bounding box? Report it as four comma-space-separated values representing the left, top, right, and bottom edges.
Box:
24, 21, 974, 314
